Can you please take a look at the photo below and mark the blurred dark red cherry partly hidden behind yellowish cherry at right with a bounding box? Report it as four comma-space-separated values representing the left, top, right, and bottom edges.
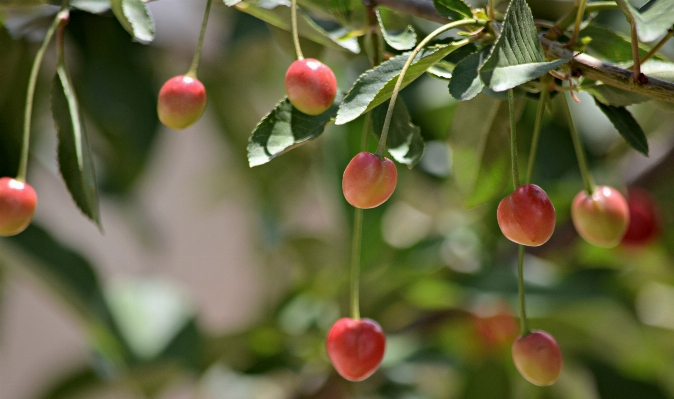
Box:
622, 187, 660, 246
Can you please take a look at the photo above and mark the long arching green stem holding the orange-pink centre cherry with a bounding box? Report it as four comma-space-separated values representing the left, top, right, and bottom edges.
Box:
374, 19, 484, 159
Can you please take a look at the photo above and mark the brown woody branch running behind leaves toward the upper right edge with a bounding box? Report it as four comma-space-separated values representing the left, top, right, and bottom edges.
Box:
370, 0, 674, 103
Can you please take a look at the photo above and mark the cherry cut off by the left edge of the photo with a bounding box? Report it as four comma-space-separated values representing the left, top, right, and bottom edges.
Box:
0, 177, 37, 236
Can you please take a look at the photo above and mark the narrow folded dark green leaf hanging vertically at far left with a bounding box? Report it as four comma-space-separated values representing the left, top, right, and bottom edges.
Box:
52, 60, 102, 229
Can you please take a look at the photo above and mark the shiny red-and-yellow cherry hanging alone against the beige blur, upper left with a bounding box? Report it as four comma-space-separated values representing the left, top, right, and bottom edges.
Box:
157, 75, 206, 130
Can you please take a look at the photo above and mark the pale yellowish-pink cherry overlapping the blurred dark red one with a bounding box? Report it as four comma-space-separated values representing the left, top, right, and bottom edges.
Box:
571, 186, 630, 248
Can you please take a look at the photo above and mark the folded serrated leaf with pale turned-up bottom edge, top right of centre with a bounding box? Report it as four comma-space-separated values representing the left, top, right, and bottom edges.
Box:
480, 0, 569, 91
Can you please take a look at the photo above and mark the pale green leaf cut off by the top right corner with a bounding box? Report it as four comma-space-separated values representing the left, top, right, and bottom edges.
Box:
616, 0, 674, 42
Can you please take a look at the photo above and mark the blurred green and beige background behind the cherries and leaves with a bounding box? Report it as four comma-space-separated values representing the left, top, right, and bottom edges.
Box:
0, 0, 674, 399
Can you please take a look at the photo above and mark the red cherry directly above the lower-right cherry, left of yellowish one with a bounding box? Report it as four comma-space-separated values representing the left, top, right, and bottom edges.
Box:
496, 184, 555, 247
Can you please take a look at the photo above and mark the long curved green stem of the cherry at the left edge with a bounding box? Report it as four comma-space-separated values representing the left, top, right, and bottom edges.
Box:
16, 5, 69, 182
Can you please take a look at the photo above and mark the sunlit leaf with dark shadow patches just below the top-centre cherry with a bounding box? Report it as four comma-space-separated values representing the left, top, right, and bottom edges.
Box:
248, 95, 341, 168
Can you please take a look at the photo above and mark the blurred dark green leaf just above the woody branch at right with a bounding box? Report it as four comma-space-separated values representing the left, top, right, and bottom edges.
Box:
580, 23, 662, 62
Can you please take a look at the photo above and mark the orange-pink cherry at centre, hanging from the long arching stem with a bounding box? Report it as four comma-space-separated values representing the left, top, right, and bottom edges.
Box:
342, 152, 398, 209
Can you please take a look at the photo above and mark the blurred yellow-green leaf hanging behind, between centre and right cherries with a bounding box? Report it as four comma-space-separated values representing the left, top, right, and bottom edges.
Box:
449, 95, 524, 208
